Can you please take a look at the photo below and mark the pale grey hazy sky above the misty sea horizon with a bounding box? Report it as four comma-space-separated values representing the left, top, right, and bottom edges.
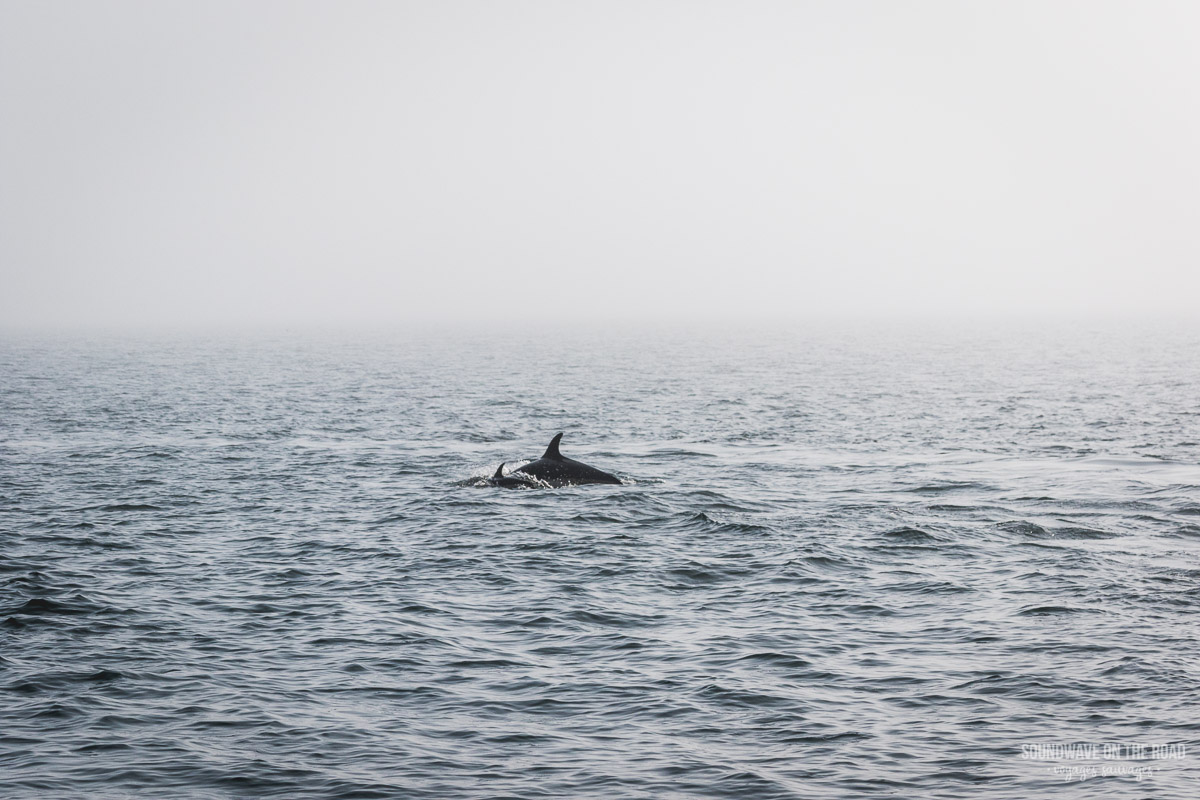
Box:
0, 0, 1200, 326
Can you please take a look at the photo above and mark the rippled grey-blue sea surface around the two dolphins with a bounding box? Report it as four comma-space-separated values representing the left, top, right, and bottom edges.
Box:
0, 323, 1200, 800
